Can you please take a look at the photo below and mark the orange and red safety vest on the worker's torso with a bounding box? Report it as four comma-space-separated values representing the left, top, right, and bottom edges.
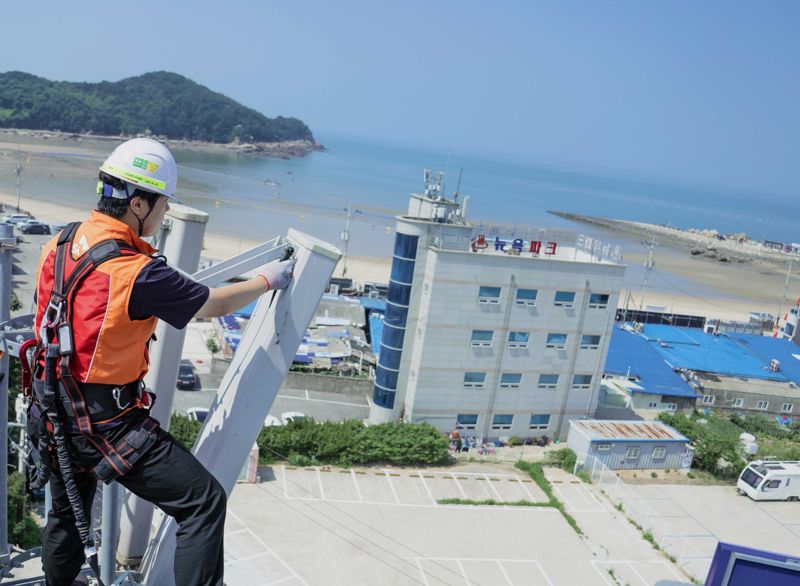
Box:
34, 210, 158, 385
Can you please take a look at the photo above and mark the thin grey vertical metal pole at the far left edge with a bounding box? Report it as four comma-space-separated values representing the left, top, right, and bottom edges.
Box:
0, 224, 16, 565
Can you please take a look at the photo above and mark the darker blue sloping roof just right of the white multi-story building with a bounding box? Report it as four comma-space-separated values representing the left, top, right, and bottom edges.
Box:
605, 327, 697, 397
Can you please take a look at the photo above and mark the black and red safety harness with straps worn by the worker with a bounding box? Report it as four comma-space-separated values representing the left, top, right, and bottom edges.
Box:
19, 222, 158, 571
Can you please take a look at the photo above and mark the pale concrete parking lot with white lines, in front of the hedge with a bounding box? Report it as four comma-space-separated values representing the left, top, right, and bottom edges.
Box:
225, 464, 685, 586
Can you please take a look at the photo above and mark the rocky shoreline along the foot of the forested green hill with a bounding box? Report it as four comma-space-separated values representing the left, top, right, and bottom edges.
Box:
0, 128, 327, 159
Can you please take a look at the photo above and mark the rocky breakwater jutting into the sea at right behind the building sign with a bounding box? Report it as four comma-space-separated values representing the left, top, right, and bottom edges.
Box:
548, 211, 795, 267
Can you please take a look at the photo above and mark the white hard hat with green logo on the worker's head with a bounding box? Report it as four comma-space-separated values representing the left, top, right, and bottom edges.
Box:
100, 138, 178, 199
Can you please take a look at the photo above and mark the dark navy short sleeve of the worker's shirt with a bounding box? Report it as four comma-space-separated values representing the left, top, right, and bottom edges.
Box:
128, 258, 209, 330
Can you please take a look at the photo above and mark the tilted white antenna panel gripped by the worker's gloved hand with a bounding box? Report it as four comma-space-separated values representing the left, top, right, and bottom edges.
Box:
140, 230, 341, 586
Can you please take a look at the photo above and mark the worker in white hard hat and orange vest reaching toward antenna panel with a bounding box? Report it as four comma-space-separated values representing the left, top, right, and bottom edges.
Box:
31, 138, 295, 586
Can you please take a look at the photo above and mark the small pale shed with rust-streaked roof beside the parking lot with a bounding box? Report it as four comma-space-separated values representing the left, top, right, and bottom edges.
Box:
567, 419, 692, 470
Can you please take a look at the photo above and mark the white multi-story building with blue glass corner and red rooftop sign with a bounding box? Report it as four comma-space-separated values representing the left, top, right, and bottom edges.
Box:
370, 178, 625, 439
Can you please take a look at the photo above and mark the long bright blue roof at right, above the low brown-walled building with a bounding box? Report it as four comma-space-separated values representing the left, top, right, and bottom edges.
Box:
642, 324, 800, 381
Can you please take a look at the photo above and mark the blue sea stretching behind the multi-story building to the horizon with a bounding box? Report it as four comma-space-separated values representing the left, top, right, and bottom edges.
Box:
0, 135, 800, 293
